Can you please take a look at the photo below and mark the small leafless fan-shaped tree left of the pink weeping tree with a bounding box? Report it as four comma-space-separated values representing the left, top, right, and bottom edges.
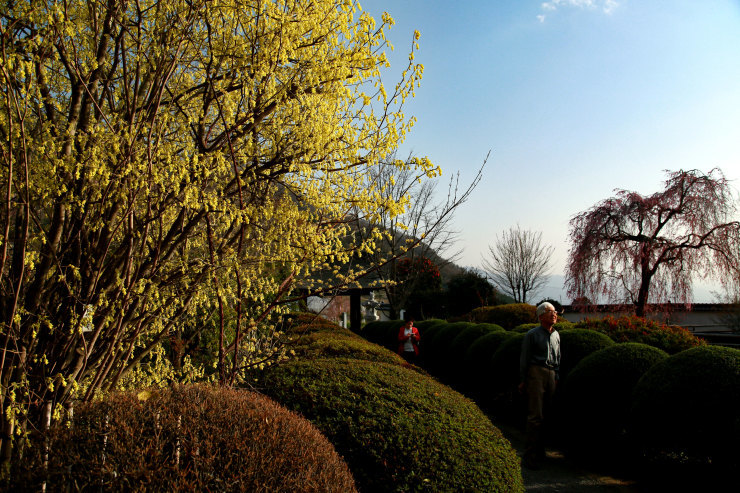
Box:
483, 225, 554, 303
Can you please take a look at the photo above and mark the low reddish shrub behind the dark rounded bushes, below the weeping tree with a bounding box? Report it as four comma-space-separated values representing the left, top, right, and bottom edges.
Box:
575, 315, 706, 354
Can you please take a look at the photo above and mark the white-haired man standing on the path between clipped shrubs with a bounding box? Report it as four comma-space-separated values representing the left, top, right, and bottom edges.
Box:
519, 302, 560, 469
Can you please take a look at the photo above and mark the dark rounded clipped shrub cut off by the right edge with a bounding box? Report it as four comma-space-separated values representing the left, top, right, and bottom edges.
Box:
631, 346, 740, 473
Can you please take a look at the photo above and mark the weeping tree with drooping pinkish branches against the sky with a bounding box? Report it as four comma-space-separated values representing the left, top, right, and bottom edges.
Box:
566, 169, 740, 316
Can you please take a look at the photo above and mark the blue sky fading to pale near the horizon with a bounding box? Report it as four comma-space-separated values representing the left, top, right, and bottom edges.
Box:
361, 0, 740, 301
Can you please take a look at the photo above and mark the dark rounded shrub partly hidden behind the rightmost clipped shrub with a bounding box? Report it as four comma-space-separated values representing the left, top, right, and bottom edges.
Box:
560, 342, 668, 464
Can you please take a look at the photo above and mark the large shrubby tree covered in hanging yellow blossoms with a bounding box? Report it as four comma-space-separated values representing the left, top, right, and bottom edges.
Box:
0, 0, 436, 457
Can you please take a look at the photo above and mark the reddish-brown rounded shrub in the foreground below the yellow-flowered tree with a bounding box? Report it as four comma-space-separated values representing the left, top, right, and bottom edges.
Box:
9, 385, 356, 493
